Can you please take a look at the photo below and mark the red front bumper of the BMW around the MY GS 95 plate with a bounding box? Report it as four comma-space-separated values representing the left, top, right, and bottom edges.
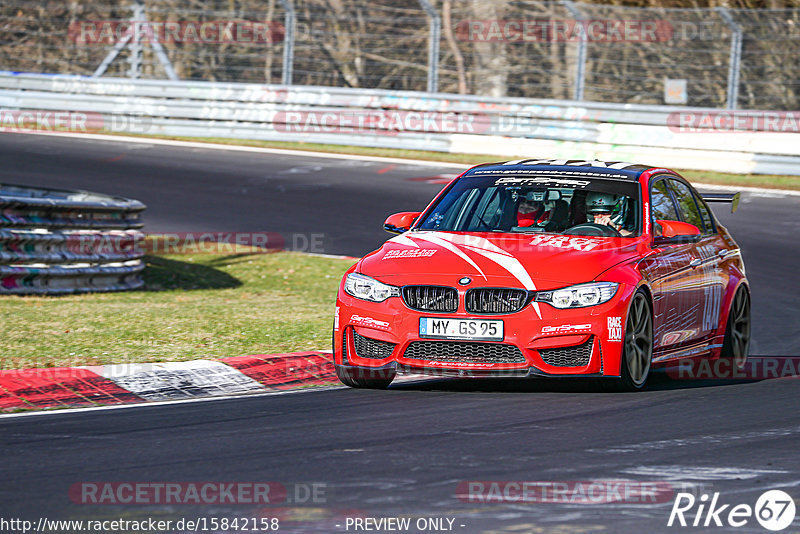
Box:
333, 285, 633, 378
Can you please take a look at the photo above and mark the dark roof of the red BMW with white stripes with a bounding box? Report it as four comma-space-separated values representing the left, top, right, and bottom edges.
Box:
464, 158, 653, 181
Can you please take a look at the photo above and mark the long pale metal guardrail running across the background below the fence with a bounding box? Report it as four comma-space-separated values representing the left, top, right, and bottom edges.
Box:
0, 72, 800, 175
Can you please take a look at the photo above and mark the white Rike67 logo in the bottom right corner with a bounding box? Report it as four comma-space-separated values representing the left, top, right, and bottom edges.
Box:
667, 490, 795, 532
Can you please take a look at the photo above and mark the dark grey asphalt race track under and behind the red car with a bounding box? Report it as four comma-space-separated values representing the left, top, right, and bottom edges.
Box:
0, 135, 800, 533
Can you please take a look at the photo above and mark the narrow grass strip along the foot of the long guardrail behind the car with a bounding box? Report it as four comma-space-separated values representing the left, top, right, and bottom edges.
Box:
117, 136, 800, 190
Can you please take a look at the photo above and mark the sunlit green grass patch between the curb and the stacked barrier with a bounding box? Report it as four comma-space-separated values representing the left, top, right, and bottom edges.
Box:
0, 252, 353, 369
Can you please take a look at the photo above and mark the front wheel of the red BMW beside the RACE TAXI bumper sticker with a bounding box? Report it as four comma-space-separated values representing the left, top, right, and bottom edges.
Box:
618, 290, 653, 391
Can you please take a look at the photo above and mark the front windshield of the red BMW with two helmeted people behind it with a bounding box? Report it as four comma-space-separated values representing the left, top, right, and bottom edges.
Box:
417, 176, 641, 237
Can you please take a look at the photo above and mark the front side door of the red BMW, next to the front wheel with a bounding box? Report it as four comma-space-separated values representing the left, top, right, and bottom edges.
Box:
639, 177, 699, 357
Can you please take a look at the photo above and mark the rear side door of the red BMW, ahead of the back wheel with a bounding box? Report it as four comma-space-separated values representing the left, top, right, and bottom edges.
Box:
669, 178, 727, 340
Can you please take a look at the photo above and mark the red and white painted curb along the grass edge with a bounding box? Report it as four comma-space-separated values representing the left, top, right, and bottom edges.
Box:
0, 352, 339, 412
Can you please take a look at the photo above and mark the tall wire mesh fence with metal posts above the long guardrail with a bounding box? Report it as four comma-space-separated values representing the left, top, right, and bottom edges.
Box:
0, 0, 800, 110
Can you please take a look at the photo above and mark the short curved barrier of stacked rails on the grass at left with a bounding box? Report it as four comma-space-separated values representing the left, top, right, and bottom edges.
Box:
0, 184, 145, 295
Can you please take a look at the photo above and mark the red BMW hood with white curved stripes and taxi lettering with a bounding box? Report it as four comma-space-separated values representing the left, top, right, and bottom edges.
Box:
358, 231, 641, 290
